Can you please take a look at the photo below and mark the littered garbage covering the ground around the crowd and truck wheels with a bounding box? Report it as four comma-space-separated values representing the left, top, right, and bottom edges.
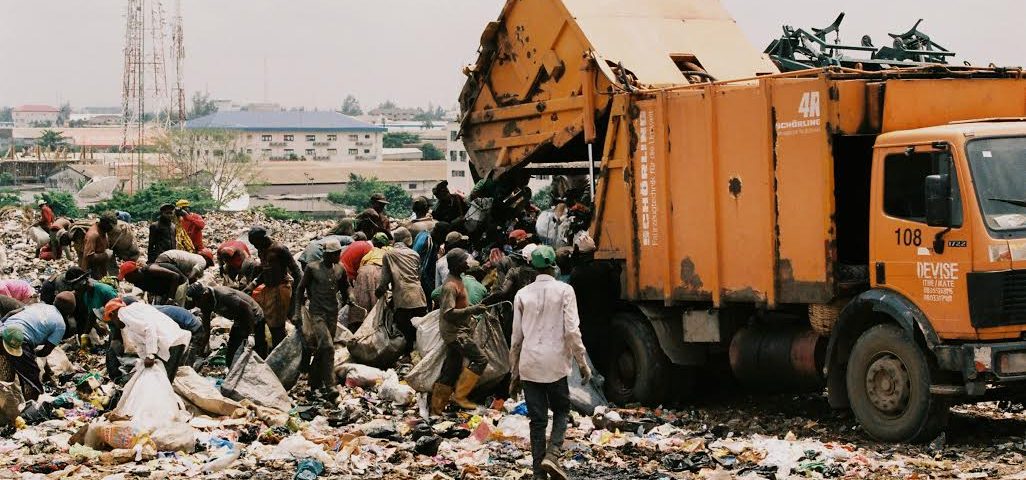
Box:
0, 209, 1026, 480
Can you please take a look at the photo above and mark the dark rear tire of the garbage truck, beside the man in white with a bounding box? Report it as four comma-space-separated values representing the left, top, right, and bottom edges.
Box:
605, 314, 669, 406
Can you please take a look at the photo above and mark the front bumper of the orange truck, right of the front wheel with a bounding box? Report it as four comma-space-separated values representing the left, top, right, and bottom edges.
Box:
933, 341, 1026, 387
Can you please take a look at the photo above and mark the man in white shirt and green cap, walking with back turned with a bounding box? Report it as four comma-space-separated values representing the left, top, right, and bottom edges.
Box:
510, 245, 591, 480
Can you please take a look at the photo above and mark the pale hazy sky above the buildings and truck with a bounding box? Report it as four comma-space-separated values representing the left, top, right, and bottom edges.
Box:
0, 0, 1026, 108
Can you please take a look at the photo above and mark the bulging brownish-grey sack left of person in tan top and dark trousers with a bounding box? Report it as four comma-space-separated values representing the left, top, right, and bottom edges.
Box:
348, 297, 406, 368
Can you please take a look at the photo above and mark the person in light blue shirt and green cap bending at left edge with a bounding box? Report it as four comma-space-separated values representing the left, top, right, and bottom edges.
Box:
0, 291, 75, 400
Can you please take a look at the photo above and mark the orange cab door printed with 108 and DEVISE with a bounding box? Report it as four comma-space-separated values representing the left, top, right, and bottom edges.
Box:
870, 144, 976, 339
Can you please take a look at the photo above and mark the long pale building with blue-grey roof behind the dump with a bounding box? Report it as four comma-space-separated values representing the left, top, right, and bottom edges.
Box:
186, 111, 387, 162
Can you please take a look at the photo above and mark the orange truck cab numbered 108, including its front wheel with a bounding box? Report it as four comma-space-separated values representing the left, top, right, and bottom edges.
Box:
835, 119, 1026, 440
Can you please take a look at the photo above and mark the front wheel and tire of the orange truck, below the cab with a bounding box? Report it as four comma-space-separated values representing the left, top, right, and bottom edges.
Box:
846, 324, 949, 442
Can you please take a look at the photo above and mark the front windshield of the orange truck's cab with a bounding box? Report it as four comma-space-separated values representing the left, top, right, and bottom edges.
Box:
965, 136, 1026, 230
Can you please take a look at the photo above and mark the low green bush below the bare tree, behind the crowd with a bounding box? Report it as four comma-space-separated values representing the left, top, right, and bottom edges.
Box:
89, 182, 215, 218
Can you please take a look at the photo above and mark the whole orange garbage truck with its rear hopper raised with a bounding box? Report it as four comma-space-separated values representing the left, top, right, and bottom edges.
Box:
461, 0, 1026, 441
